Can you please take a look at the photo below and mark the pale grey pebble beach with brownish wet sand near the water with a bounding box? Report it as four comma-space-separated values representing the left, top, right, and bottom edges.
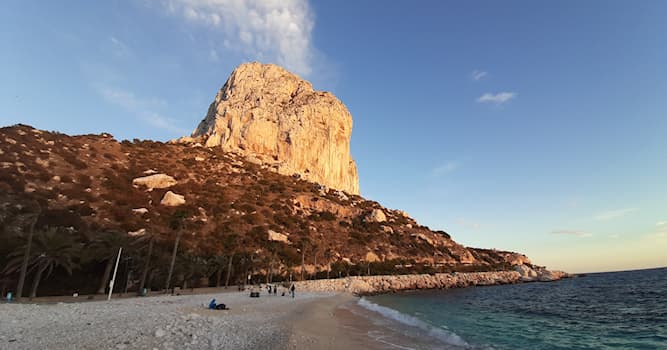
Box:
0, 291, 392, 350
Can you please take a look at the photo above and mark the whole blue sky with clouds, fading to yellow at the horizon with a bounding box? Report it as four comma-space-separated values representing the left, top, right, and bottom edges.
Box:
0, 0, 667, 272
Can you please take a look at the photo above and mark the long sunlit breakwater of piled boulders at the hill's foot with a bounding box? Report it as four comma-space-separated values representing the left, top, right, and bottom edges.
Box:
296, 270, 569, 295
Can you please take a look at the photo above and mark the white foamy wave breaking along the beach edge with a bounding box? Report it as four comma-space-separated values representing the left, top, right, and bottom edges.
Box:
357, 298, 473, 349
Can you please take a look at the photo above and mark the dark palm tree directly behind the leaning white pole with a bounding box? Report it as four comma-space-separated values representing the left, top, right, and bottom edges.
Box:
88, 231, 128, 294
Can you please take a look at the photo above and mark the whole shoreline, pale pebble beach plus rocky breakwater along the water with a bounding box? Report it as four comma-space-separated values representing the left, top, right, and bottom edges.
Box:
0, 271, 576, 350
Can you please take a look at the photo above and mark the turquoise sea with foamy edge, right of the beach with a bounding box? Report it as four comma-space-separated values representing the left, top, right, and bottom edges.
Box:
366, 268, 667, 350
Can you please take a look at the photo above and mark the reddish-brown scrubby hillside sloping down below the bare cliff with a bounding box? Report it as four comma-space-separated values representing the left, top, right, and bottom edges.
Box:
0, 125, 527, 296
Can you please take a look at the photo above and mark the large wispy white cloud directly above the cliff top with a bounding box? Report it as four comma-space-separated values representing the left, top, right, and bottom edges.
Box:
159, 0, 314, 75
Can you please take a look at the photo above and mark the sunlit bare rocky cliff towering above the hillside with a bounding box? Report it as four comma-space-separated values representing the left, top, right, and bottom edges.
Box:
181, 62, 359, 194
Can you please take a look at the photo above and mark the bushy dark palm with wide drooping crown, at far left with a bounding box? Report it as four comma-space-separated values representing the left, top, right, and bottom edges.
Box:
5, 227, 80, 298
